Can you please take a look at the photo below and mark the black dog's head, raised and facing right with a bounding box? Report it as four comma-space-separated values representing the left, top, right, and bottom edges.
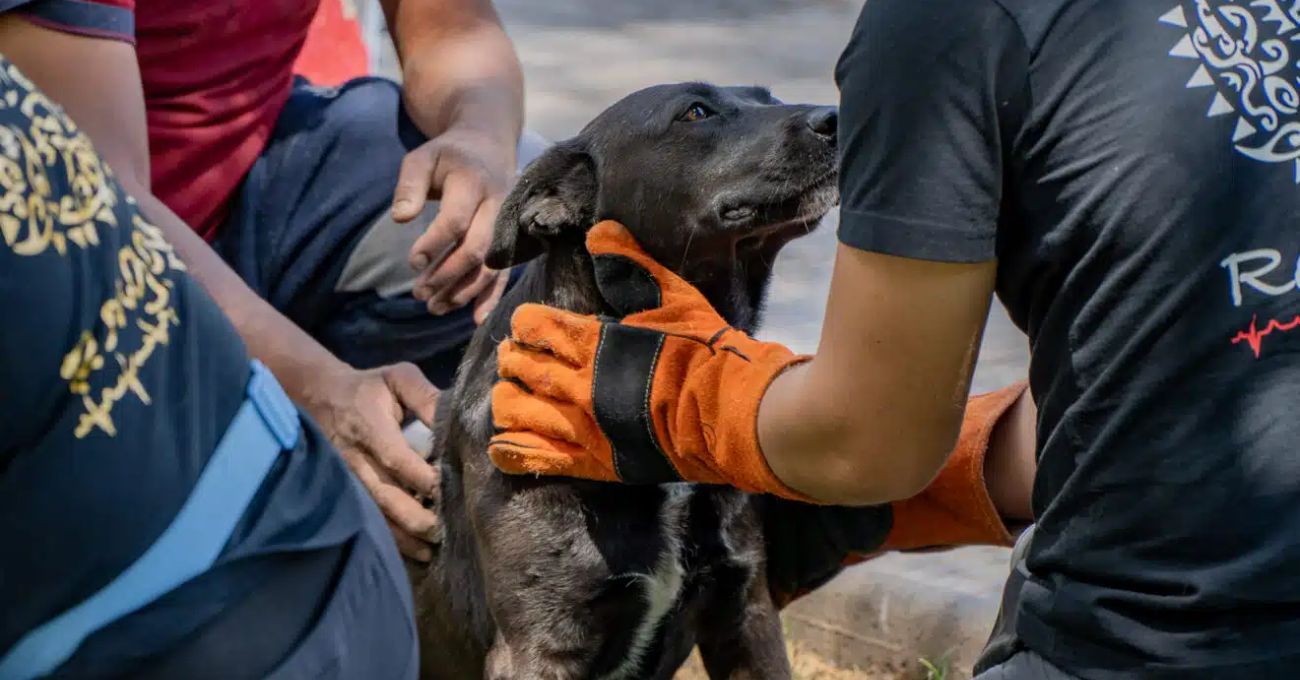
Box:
488, 83, 839, 330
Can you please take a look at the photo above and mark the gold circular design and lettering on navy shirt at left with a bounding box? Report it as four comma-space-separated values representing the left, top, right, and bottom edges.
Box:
0, 57, 185, 438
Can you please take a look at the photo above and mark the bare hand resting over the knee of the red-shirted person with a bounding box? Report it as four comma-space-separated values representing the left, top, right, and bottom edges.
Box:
393, 127, 515, 324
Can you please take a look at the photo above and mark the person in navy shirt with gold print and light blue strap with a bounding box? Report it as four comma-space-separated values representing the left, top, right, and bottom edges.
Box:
0, 56, 417, 680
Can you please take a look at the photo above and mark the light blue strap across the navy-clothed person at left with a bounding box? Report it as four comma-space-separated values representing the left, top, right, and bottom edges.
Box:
0, 360, 300, 680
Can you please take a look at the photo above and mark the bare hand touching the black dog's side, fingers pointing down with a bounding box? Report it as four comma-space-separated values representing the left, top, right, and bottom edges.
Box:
302, 364, 441, 562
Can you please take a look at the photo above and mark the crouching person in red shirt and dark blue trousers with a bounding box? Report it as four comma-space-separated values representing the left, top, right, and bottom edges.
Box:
0, 0, 527, 558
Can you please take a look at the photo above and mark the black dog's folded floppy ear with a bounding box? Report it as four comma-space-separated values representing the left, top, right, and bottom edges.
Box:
485, 140, 595, 269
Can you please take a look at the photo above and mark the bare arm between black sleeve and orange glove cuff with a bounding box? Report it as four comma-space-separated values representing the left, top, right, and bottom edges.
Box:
758, 246, 996, 504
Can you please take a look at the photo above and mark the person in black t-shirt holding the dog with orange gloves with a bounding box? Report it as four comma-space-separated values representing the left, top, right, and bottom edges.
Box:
493, 0, 1300, 679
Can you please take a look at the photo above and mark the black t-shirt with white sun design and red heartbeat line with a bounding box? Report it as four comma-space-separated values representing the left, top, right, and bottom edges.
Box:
837, 0, 1300, 679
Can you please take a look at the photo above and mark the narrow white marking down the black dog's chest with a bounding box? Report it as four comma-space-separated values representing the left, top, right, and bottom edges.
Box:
602, 484, 696, 680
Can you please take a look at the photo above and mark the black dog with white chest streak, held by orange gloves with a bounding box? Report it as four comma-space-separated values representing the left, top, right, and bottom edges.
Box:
413, 83, 837, 680
